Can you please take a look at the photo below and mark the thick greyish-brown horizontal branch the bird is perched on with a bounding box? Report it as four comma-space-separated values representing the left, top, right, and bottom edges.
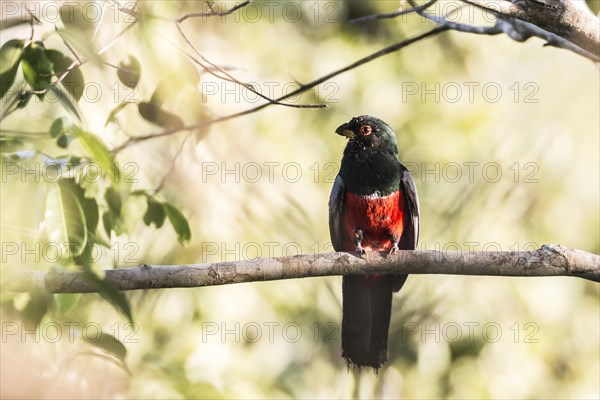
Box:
4, 245, 600, 293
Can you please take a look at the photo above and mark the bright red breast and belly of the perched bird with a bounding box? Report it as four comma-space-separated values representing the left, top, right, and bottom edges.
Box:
342, 190, 409, 251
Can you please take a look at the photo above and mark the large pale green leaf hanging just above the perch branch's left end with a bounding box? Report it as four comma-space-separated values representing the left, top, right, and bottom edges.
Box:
45, 179, 88, 257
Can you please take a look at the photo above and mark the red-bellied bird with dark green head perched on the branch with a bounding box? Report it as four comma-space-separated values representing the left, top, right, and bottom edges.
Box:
329, 115, 419, 372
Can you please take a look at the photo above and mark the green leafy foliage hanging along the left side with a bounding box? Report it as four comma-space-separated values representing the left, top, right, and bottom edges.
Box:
0, 3, 191, 376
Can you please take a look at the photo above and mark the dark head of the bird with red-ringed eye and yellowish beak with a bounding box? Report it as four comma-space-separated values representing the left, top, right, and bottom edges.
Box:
335, 115, 398, 154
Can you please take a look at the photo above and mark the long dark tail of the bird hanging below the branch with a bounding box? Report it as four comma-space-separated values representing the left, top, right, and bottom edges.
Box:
342, 275, 403, 369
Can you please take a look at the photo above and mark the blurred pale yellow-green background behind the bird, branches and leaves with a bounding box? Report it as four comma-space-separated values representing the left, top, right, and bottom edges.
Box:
0, 1, 600, 399
